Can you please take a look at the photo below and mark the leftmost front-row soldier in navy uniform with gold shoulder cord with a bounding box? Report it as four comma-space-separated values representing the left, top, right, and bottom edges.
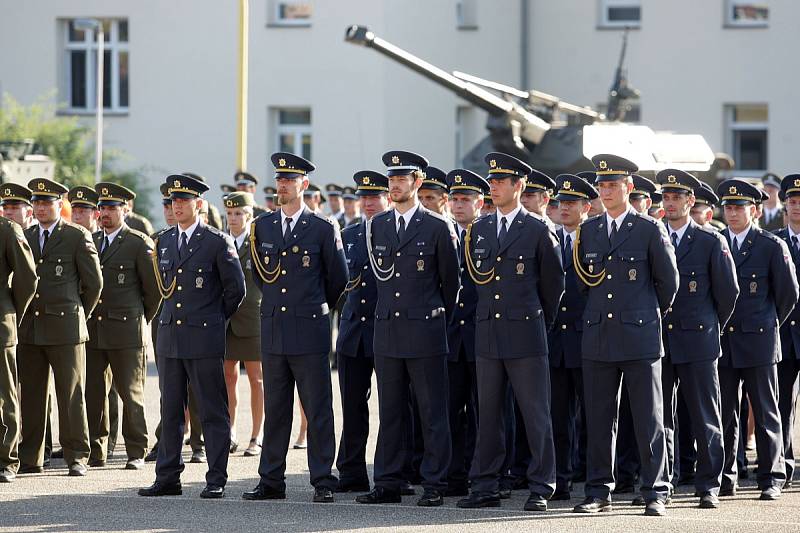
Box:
139, 174, 245, 498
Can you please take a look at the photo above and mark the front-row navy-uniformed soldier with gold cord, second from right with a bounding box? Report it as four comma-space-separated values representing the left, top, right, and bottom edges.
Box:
458, 152, 564, 511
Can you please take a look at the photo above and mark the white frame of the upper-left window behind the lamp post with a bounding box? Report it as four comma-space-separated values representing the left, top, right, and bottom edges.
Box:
60, 18, 131, 115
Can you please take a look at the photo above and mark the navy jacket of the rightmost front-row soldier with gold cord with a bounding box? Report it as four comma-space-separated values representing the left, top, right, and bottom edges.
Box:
577, 209, 678, 362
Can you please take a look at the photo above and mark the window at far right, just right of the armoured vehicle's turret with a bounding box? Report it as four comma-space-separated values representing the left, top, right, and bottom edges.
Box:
725, 104, 769, 176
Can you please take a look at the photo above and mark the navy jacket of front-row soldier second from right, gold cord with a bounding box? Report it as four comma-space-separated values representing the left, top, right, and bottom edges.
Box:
470, 207, 564, 359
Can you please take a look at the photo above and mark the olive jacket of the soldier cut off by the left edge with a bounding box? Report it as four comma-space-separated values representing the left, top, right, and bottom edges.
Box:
0, 217, 36, 347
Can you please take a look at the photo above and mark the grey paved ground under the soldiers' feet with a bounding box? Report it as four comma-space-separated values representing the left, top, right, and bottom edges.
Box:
0, 363, 800, 533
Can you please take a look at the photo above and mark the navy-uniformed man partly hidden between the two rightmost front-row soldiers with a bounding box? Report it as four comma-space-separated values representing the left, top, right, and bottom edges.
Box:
548, 174, 597, 500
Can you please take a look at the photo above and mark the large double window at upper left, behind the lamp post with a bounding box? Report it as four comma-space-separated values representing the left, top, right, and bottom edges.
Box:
64, 19, 130, 112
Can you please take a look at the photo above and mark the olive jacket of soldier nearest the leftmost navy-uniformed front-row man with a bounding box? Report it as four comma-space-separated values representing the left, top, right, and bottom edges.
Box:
86, 223, 161, 350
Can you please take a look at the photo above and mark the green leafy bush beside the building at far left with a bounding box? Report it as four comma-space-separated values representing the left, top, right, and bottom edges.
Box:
0, 91, 152, 216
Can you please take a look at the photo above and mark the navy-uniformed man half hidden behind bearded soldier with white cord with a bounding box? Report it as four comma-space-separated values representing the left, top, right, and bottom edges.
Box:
336, 170, 389, 492
